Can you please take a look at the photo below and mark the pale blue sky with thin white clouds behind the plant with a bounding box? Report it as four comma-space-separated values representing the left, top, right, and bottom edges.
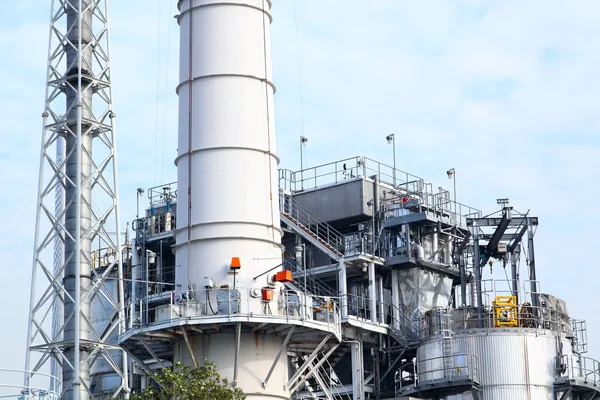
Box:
0, 0, 600, 378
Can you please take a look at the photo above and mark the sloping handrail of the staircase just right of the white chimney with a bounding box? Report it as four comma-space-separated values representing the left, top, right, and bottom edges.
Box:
279, 196, 345, 254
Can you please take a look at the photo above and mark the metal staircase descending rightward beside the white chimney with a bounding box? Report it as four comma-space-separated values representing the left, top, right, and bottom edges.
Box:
279, 195, 344, 260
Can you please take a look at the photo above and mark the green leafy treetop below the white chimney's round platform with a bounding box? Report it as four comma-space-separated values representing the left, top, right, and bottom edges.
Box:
131, 361, 246, 400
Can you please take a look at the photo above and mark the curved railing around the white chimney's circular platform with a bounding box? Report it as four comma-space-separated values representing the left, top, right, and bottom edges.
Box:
126, 287, 341, 340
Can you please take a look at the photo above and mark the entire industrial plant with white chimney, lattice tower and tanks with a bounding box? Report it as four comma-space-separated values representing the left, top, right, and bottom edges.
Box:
10, 0, 600, 400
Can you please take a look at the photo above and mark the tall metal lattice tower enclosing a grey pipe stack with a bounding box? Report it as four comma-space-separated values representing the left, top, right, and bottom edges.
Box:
24, 0, 128, 400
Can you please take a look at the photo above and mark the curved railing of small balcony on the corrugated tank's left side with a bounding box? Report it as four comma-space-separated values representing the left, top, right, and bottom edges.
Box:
396, 353, 479, 397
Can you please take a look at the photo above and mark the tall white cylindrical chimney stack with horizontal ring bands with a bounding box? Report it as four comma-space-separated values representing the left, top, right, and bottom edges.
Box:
175, 0, 289, 399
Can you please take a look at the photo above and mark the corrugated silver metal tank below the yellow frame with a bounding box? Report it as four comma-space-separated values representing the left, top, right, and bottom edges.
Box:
417, 329, 571, 400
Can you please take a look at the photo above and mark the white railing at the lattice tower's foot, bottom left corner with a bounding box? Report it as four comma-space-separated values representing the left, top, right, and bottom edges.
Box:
0, 368, 61, 400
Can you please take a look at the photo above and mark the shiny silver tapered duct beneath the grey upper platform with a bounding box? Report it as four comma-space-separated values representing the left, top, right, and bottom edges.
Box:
398, 268, 452, 313
